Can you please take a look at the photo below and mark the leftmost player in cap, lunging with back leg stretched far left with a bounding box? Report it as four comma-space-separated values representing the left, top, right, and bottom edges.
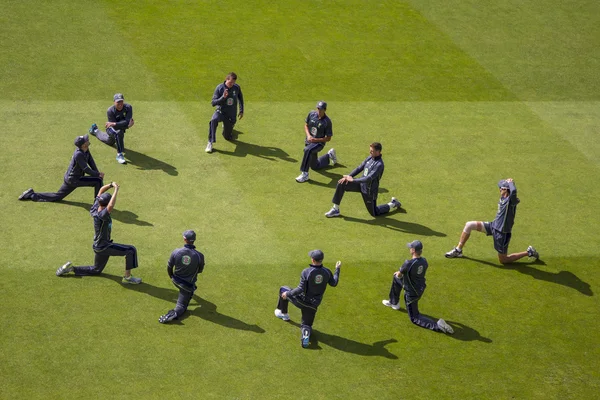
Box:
19, 135, 104, 202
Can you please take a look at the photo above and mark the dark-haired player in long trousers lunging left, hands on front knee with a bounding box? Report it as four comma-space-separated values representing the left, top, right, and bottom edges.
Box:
325, 142, 402, 218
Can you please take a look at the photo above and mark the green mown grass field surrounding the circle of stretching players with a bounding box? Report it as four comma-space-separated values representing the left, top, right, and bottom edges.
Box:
0, 0, 600, 399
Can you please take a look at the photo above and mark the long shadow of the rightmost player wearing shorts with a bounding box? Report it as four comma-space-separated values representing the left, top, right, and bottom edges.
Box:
463, 257, 594, 296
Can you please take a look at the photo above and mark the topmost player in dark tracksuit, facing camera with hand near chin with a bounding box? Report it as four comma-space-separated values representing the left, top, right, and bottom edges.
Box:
205, 72, 244, 153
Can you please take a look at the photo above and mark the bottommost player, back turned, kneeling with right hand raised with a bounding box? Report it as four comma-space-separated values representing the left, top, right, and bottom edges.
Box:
275, 250, 342, 348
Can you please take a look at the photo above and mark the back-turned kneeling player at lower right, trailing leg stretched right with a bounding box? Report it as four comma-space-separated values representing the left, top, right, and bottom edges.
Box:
382, 240, 454, 334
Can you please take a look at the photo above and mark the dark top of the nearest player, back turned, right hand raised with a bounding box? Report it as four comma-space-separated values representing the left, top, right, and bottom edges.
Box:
288, 264, 340, 310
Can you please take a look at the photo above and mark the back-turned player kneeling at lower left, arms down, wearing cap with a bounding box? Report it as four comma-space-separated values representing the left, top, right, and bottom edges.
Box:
158, 230, 204, 324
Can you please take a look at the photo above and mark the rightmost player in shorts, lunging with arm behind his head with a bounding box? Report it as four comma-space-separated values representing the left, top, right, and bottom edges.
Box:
446, 178, 540, 264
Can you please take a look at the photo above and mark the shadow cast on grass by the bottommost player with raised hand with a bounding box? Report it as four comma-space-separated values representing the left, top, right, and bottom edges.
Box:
290, 321, 398, 360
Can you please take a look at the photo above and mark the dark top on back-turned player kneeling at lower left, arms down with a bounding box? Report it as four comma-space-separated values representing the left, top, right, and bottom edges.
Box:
167, 244, 204, 292
